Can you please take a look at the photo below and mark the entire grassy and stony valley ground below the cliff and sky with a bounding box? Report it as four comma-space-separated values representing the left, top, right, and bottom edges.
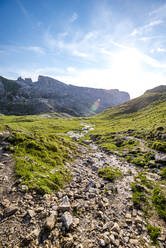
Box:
0, 87, 166, 248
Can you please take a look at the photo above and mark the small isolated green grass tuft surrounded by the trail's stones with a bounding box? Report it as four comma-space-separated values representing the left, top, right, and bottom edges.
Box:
98, 167, 123, 182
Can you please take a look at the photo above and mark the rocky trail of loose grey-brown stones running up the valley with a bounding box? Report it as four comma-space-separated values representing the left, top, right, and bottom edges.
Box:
0, 125, 166, 248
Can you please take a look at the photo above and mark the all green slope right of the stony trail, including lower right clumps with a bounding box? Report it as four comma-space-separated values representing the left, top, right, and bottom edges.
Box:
87, 91, 166, 226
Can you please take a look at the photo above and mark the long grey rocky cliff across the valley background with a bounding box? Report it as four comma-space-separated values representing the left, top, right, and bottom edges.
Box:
0, 76, 130, 116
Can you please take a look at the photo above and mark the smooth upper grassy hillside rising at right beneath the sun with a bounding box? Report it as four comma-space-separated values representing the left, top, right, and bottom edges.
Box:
91, 92, 166, 133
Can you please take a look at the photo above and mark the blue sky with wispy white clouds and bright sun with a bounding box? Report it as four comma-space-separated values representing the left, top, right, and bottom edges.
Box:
0, 0, 166, 98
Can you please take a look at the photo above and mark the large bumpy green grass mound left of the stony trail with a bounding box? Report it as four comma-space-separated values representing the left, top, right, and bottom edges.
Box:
9, 132, 76, 194
